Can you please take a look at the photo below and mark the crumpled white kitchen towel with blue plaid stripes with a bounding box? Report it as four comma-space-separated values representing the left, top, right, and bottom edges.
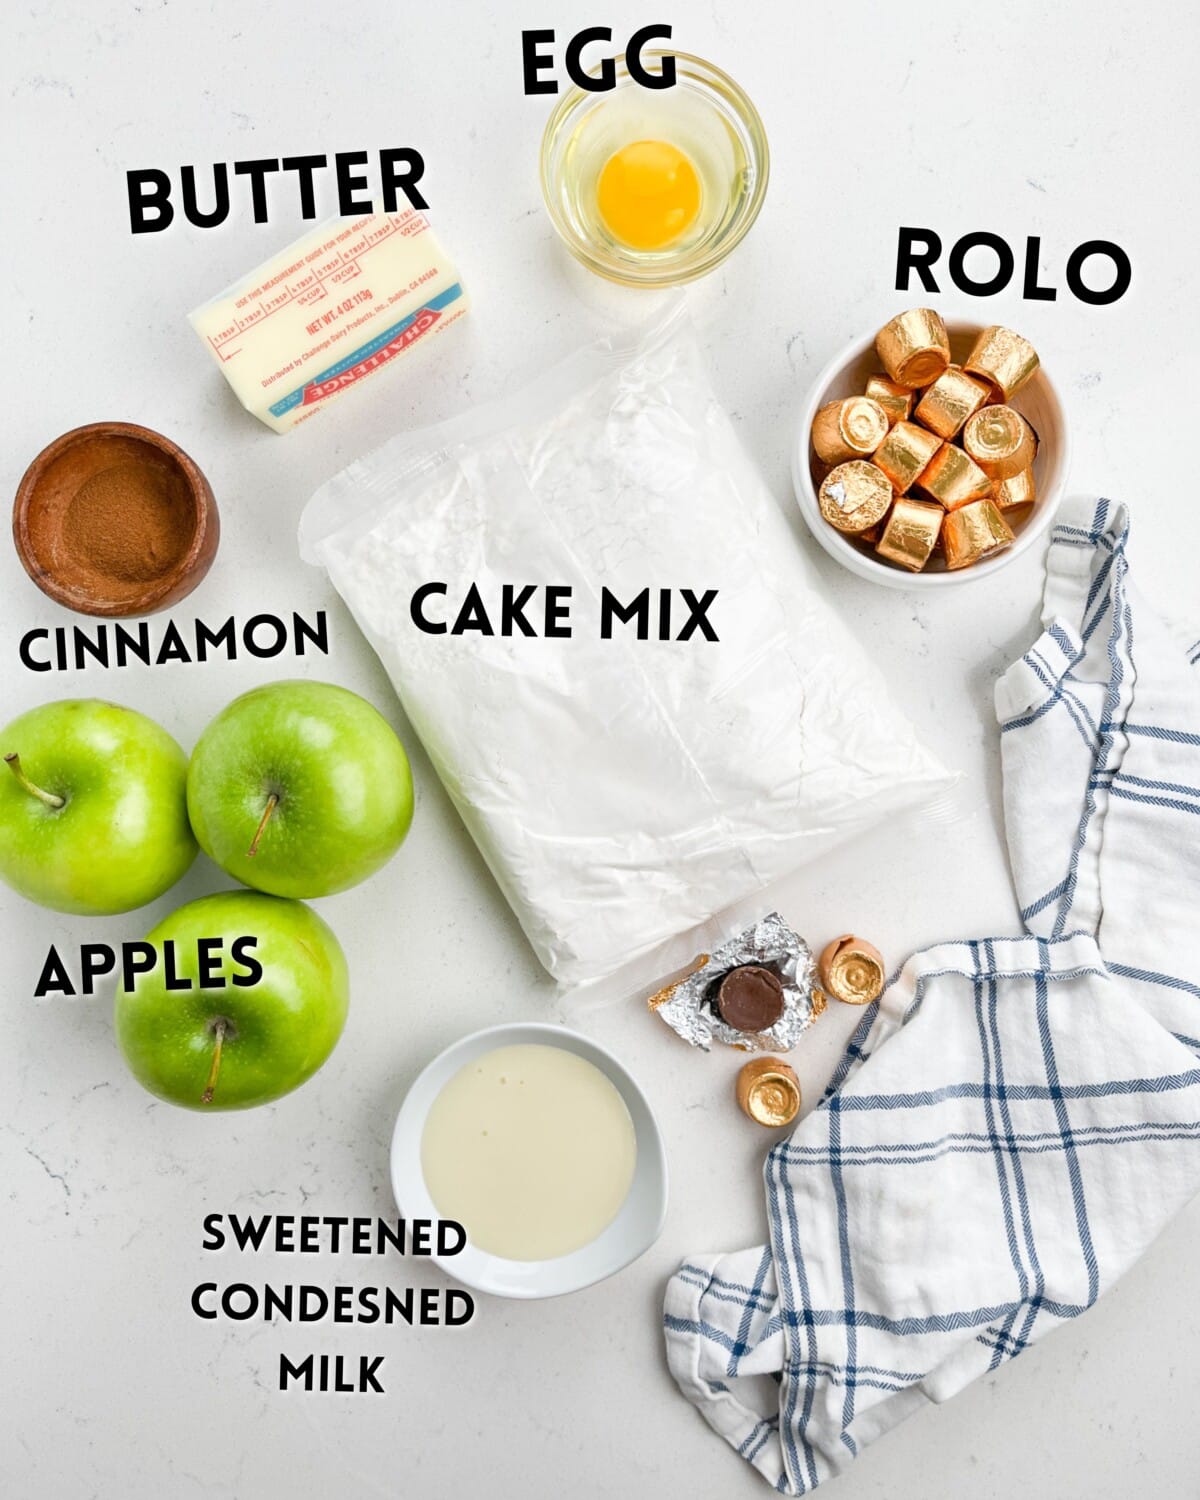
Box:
665, 501, 1200, 1494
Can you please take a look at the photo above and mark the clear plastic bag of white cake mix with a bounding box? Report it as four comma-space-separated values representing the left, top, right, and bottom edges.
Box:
300, 309, 954, 984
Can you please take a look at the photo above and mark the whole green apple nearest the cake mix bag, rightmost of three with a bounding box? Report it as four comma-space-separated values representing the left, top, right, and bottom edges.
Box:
188, 683, 413, 897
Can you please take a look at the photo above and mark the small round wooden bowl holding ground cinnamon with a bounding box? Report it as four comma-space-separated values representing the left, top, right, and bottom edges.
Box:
12, 422, 221, 618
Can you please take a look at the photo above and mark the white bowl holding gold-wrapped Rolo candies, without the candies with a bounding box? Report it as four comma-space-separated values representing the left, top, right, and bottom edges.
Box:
792, 318, 1071, 591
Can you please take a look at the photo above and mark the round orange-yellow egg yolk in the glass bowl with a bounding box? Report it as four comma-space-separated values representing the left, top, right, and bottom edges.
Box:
596, 141, 701, 251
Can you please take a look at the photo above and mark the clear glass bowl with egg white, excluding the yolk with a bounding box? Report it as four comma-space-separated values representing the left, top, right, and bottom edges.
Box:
542, 51, 770, 287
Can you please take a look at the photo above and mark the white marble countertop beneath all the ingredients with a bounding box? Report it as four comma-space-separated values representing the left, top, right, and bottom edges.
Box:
0, 0, 1200, 1500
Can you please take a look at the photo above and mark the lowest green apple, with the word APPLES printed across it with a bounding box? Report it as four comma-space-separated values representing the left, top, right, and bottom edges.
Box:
116, 891, 350, 1110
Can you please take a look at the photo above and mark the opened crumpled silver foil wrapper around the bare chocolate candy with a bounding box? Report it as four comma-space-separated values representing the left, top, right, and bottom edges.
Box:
650, 912, 825, 1052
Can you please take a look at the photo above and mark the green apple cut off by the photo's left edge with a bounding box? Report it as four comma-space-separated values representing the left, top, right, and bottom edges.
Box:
0, 698, 197, 917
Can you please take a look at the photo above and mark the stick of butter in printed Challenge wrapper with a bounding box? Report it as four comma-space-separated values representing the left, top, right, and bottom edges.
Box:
189, 209, 467, 432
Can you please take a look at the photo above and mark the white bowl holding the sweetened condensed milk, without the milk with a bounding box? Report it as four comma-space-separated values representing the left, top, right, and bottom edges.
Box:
392, 1022, 668, 1298
